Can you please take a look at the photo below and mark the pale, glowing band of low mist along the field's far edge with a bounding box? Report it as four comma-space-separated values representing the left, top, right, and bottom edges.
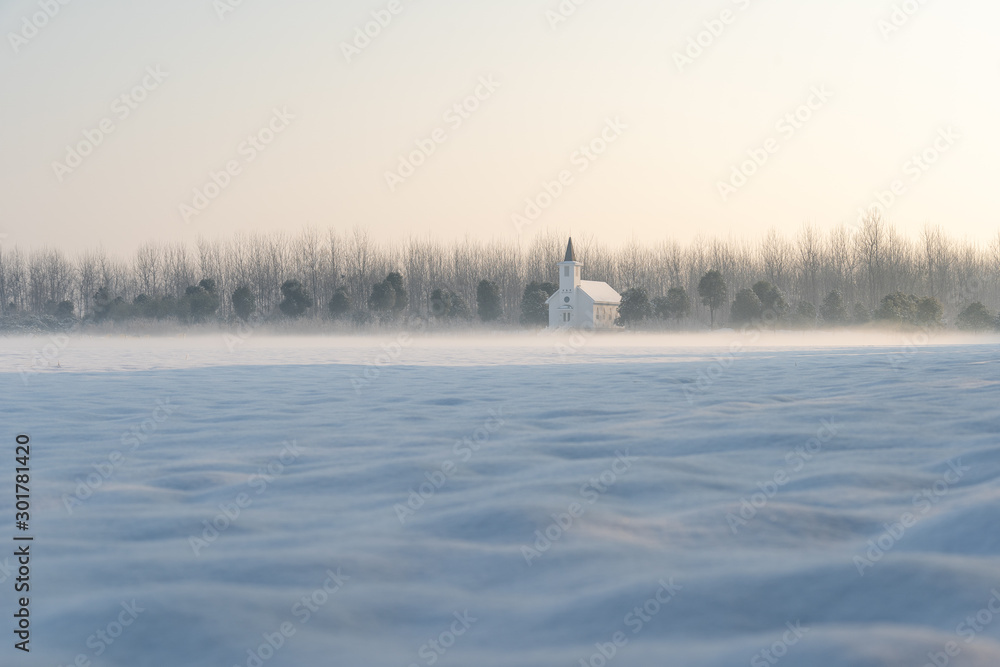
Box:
0, 327, 1000, 377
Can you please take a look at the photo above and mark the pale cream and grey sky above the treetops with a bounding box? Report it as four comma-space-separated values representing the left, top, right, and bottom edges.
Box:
0, 0, 1000, 251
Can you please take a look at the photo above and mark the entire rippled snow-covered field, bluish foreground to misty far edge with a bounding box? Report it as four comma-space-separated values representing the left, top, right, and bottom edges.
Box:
0, 332, 1000, 667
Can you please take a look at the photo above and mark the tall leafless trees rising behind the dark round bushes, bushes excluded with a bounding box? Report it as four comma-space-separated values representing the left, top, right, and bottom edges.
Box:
0, 224, 1000, 324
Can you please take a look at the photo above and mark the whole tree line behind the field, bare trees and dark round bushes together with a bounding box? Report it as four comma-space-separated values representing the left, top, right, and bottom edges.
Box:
0, 210, 1000, 328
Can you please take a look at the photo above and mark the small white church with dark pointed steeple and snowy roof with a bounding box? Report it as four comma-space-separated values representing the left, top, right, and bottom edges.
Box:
546, 239, 622, 329
